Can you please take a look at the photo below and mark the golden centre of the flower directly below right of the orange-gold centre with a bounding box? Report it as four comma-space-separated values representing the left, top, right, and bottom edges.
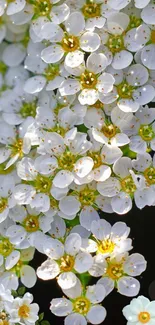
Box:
80, 70, 97, 89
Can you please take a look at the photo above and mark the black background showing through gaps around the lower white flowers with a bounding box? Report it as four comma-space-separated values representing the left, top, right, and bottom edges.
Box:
29, 206, 155, 325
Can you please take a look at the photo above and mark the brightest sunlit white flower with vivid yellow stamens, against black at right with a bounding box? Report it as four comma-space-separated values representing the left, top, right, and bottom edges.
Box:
91, 219, 132, 257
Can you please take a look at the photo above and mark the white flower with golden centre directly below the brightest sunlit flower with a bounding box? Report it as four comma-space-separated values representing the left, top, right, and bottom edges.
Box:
89, 253, 146, 297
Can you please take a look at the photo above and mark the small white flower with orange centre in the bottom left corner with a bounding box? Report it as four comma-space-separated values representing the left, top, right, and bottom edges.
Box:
10, 292, 39, 325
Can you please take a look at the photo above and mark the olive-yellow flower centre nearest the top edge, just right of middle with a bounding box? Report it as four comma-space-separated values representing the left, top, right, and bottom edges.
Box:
81, 1, 101, 19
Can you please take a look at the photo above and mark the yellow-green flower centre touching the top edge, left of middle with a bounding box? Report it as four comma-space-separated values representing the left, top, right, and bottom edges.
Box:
28, 0, 52, 16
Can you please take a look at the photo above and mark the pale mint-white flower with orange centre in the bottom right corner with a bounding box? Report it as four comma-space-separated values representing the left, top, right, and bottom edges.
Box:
122, 296, 155, 325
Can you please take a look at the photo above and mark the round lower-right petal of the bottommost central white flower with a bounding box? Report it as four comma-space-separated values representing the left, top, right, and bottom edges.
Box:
87, 305, 107, 324
